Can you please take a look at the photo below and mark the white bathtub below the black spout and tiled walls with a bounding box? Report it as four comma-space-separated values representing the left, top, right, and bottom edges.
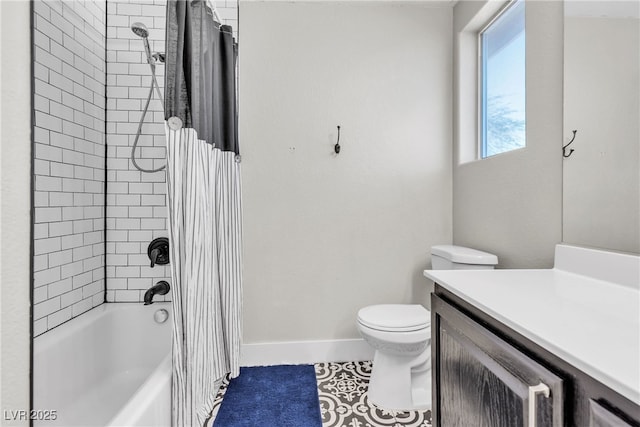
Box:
32, 303, 171, 427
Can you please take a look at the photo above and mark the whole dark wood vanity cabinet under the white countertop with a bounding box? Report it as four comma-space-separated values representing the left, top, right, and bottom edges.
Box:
431, 284, 640, 427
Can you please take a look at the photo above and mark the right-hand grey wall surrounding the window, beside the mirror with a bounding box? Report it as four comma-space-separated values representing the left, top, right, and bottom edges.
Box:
453, 1, 563, 268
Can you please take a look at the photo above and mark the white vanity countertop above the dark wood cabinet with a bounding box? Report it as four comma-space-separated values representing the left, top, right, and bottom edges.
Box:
424, 268, 640, 403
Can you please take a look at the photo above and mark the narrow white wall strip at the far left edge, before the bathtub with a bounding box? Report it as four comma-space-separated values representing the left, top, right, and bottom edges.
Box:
0, 1, 31, 426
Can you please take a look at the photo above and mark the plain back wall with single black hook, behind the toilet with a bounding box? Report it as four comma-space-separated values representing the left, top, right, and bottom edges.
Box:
239, 2, 452, 343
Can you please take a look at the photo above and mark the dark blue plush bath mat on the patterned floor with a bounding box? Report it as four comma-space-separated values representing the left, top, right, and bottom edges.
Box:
213, 365, 322, 427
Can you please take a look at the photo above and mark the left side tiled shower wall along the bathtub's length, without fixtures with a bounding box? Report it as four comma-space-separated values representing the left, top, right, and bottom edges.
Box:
33, 0, 106, 336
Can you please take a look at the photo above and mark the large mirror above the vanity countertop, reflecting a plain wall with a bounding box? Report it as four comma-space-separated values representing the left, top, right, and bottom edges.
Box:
563, 0, 640, 253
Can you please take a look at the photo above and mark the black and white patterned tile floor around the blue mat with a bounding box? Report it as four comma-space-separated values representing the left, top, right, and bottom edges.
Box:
207, 362, 431, 427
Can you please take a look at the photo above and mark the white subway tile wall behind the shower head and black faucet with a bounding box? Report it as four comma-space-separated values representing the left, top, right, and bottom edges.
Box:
107, 0, 237, 302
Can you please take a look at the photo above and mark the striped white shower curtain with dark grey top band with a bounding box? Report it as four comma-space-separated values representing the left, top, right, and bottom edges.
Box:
165, 0, 242, 427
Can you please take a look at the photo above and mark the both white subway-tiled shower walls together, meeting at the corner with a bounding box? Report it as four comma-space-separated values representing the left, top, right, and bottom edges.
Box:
34, 0, 238, 328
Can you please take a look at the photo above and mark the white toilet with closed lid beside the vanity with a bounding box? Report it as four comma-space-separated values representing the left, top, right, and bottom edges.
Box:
357, 245, 498, 411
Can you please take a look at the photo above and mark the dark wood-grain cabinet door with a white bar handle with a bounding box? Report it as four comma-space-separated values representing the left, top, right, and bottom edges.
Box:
432, 295, 564, 427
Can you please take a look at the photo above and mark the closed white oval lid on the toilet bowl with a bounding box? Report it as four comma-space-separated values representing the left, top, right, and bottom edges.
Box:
358, 304, 431, 332
